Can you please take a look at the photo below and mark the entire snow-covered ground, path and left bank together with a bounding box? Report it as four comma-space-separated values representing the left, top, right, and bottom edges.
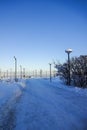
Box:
0, 78, 87, 130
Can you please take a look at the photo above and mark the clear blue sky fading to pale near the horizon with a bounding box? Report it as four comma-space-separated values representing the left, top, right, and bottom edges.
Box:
0, 0, 87, 70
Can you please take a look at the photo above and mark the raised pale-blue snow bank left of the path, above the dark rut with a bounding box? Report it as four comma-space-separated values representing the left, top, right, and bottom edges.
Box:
0, 80, 25, 125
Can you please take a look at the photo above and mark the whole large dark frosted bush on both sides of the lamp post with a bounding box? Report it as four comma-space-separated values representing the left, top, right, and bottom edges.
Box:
55, 56, 87, 88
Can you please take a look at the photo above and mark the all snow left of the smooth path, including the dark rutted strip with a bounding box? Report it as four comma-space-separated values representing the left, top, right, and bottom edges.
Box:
0, 80, 25, 130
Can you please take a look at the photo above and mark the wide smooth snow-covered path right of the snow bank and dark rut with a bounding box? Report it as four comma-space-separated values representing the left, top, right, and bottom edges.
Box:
15, 79, 87, 130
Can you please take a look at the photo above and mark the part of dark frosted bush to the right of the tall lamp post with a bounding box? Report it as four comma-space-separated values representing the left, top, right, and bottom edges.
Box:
71, 56, 87, 88
